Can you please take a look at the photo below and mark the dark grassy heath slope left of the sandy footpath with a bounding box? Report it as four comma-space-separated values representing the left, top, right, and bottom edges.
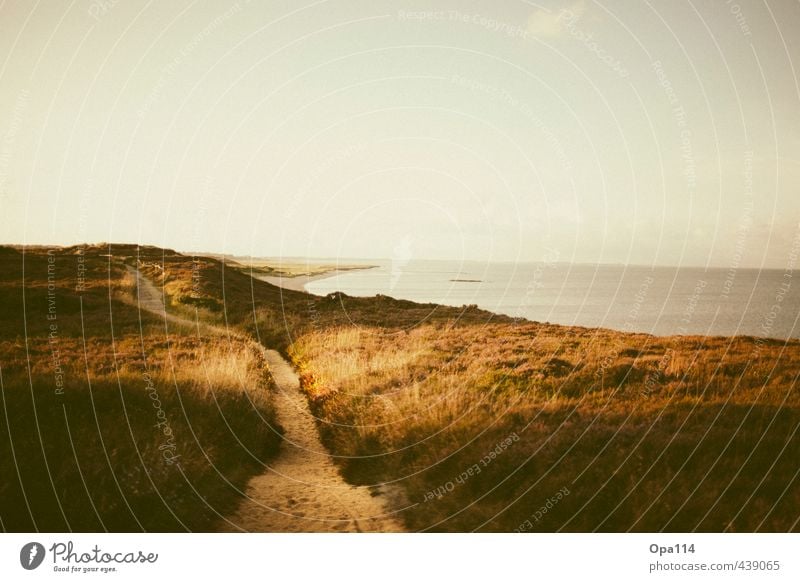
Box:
0, 247, 279, 531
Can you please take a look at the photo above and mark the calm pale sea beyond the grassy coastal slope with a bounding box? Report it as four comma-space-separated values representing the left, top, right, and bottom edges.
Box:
306, 261, 800, 338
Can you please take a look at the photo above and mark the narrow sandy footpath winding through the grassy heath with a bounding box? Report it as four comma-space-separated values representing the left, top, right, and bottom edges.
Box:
128, 267, 405, 532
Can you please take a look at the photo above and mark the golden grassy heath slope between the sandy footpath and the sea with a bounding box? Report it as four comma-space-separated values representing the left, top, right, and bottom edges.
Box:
0, 248, 800, 531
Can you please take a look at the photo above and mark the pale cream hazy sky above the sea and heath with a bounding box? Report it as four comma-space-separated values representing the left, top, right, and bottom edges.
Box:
0, 0, 800, 268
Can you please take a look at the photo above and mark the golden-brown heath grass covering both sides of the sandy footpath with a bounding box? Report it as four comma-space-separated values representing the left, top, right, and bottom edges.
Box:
0, 245, 800, 531
